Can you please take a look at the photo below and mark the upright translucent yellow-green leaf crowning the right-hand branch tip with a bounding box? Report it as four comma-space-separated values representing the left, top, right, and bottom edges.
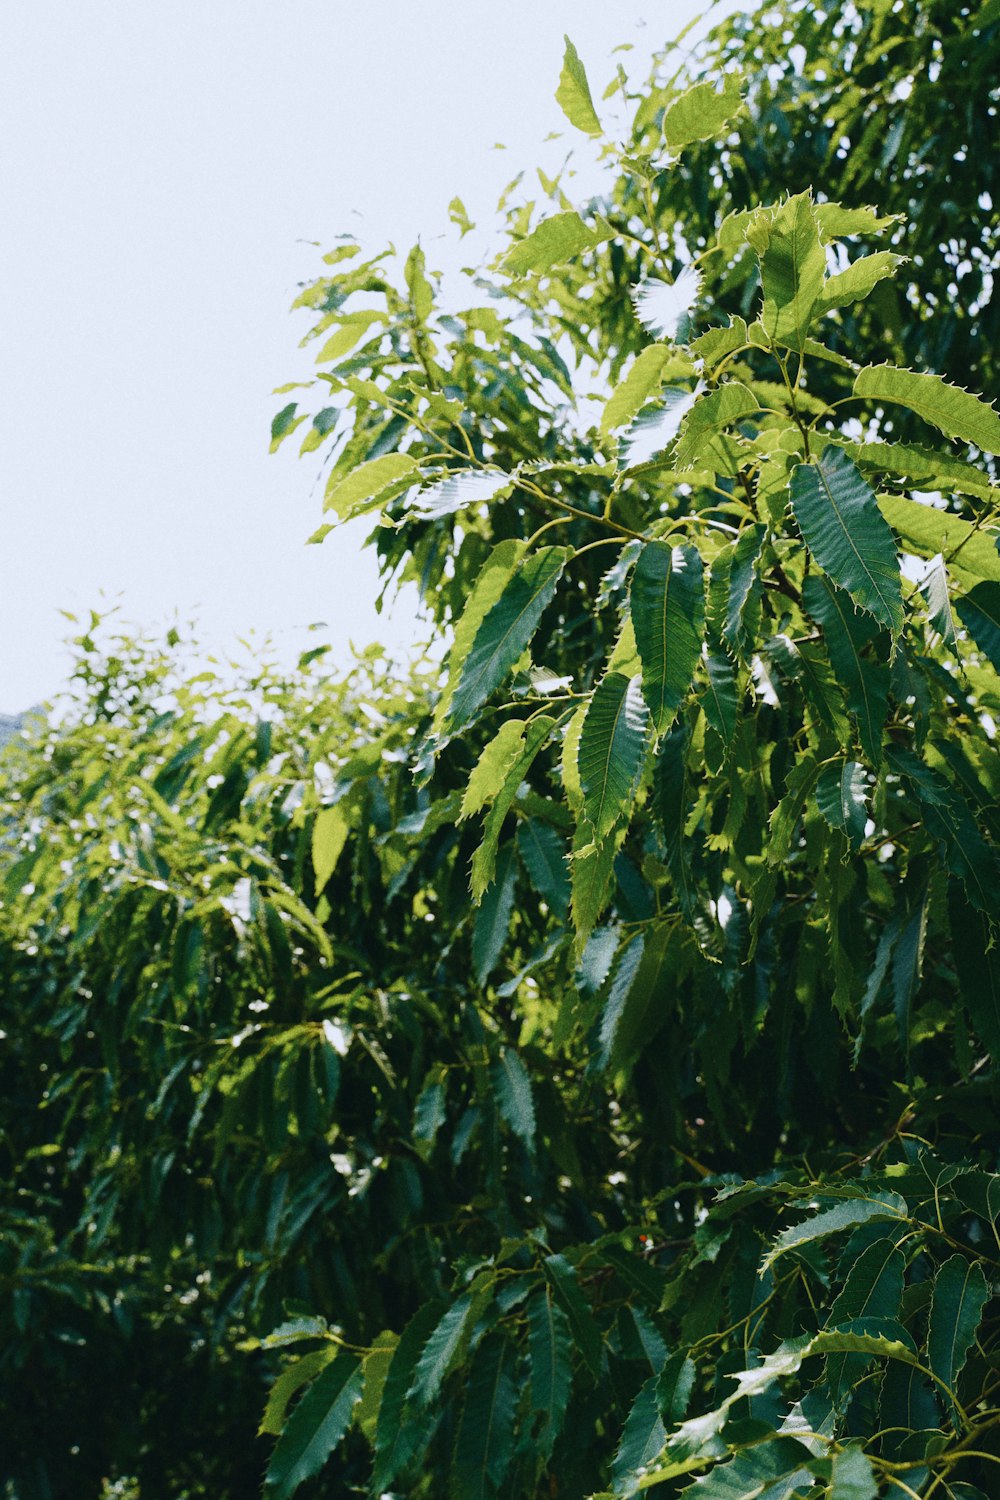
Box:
747, 192, 826, 351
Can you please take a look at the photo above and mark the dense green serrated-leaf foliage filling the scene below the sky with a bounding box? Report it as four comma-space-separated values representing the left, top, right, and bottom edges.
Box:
3, 5, 1000, 1500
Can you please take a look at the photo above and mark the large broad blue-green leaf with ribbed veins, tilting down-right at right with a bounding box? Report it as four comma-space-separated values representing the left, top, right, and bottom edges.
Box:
792, 444, 903, 635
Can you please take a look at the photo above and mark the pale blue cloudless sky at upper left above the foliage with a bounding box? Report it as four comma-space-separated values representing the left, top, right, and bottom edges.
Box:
0, 0, 732, 711
